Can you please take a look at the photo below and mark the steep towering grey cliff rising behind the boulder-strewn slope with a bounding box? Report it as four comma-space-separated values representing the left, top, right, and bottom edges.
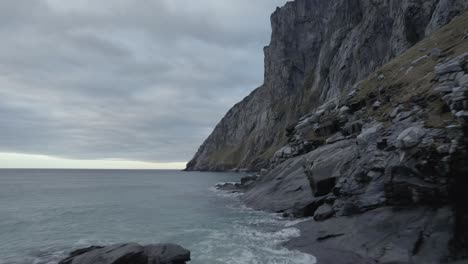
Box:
187, 0, 468, 171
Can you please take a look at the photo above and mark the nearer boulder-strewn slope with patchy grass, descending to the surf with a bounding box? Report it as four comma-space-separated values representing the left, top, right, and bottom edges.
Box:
217, 9, 468, 264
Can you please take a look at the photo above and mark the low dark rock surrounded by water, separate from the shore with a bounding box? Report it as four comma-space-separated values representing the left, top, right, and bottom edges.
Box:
59, 243, 190, 264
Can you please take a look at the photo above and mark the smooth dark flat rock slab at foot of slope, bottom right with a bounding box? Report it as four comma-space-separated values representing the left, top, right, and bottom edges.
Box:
285, 207, 453, 264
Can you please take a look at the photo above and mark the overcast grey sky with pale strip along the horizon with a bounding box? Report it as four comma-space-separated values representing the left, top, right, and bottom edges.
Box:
0, 0, 286, 169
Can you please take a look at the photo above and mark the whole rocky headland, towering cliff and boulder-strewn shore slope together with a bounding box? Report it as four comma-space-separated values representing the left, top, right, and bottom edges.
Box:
187, 0, 468, 264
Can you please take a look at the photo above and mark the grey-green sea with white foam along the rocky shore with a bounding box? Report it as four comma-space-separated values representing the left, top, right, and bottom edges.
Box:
0, 170, 315, 264
